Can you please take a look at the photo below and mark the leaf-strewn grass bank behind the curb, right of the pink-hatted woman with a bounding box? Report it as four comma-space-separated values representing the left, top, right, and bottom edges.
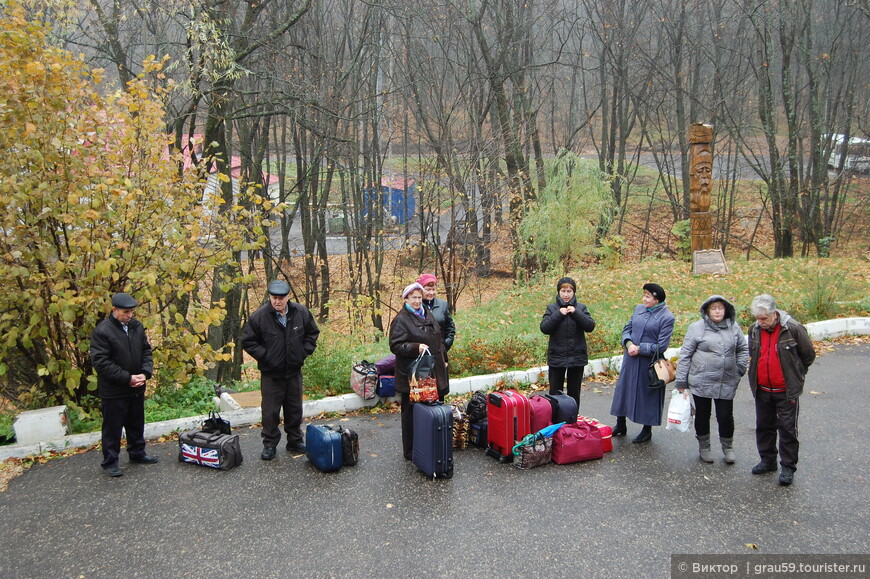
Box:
450, 258, 870, 376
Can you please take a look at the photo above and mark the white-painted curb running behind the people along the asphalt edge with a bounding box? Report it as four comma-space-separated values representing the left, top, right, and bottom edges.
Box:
0, 317, 870, 461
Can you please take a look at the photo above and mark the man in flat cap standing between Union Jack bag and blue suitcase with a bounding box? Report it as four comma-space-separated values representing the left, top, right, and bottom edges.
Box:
241, 280, 320, 460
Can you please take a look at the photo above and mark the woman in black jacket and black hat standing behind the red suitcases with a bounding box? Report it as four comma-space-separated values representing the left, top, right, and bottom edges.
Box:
541, 277, 595, 408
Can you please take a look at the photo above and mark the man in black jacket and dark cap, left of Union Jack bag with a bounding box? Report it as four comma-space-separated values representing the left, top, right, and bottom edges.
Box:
91, 293, 157, 477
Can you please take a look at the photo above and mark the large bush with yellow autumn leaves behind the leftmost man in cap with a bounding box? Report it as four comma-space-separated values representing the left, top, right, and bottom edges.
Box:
0, 3, 270, 406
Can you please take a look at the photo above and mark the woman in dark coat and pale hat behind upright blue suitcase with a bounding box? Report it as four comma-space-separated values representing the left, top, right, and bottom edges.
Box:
390, 282, 450, 460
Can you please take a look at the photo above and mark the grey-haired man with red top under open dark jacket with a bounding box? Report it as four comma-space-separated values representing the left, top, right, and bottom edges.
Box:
749, 294, 816, 486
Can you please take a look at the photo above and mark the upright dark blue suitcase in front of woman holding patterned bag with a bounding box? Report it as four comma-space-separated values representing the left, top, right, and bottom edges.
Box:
412, 402, 453, 478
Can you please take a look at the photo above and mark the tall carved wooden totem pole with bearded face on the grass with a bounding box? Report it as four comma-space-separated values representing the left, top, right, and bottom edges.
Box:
689, 123, 713, 252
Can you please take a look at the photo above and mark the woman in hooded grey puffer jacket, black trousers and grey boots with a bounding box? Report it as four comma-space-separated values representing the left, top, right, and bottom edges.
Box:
675, 295, 749, 464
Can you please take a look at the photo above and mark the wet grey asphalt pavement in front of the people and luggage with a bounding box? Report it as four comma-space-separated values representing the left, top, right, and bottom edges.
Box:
0, 344, 870, 578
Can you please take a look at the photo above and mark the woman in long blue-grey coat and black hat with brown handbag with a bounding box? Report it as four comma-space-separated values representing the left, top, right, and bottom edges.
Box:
610, 283, 674, 443
